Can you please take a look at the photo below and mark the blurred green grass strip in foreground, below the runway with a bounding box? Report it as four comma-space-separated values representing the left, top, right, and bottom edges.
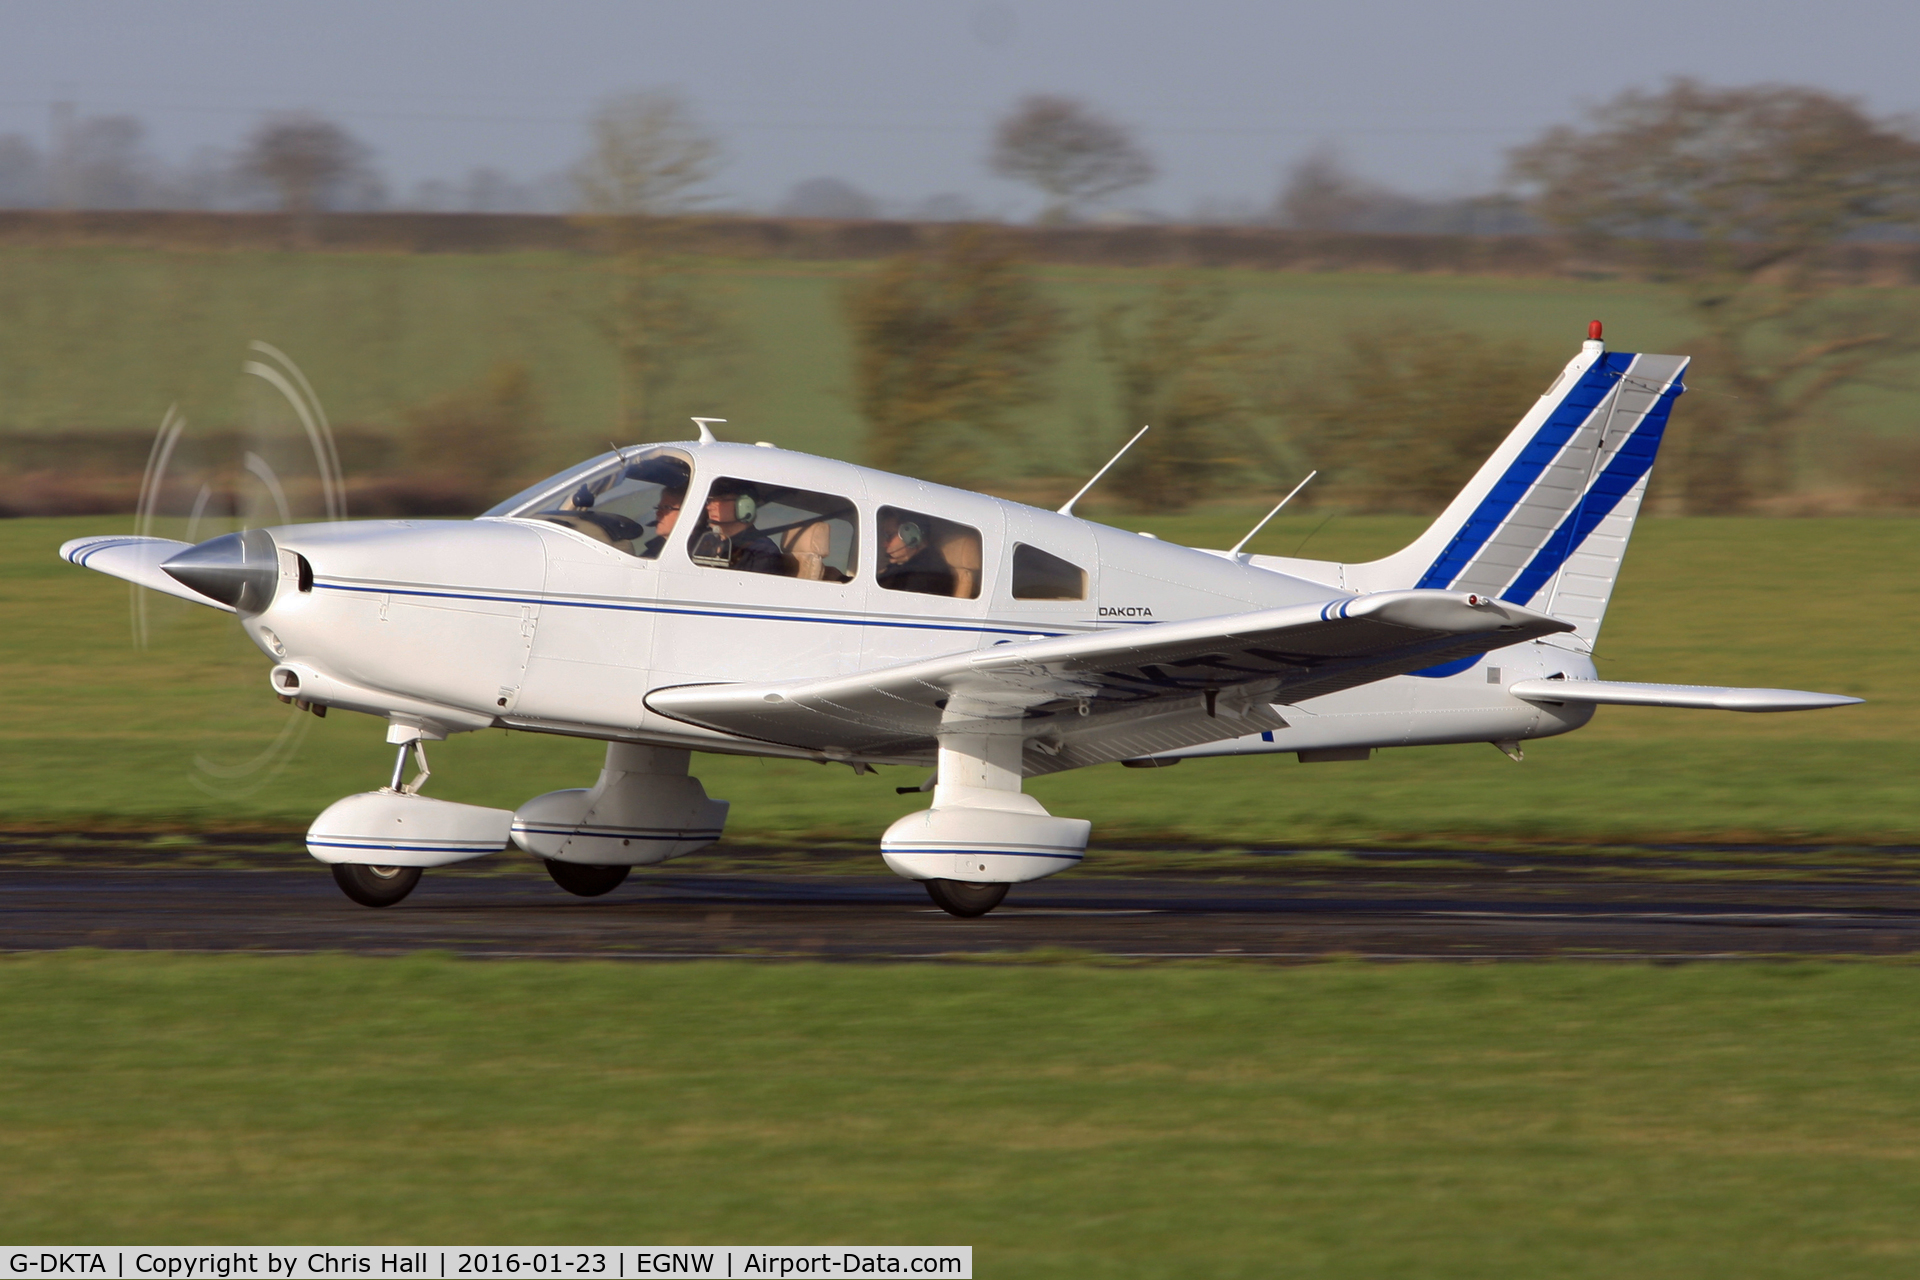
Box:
0, 954, 1920, 1280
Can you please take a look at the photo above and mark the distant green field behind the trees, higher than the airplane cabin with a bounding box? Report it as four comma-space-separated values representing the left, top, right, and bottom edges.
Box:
0, 239, 1889, 474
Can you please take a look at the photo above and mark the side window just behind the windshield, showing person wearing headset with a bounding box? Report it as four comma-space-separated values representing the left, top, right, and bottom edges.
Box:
687, 476, 858, 581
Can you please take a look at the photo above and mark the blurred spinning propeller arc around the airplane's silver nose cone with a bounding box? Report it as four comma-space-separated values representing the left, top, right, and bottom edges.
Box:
131, 342, 348, 798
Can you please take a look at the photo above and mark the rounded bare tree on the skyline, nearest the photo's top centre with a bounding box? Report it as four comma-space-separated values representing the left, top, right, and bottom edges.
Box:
991, 94, 1154, 223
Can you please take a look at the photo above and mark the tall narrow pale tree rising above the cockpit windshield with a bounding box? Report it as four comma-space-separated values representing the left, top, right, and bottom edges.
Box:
574, 92, 732, 439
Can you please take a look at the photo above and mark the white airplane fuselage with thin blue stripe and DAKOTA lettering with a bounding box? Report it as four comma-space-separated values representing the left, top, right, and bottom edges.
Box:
244, 443, 1594, 762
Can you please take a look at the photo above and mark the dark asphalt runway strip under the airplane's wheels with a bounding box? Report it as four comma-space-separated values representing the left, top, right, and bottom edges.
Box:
0, 852, 1920, 961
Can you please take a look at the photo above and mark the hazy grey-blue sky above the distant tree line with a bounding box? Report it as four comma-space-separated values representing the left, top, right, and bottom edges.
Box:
0, 0, 1920, 215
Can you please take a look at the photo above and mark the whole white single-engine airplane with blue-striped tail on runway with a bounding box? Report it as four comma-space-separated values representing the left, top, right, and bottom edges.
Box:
61, 322, 1859, 915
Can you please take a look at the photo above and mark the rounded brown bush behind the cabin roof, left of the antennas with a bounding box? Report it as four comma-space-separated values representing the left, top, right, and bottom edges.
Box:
845, 226, 1062, 484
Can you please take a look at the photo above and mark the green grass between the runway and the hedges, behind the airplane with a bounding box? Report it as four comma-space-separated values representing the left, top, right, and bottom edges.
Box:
0, 510, 1920, 846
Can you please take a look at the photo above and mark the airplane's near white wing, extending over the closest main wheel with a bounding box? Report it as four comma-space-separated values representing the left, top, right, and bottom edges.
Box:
647, 591, 1572, 773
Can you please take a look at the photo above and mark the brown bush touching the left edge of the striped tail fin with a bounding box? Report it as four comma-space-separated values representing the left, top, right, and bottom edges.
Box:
1286, 319, 1553, 514
